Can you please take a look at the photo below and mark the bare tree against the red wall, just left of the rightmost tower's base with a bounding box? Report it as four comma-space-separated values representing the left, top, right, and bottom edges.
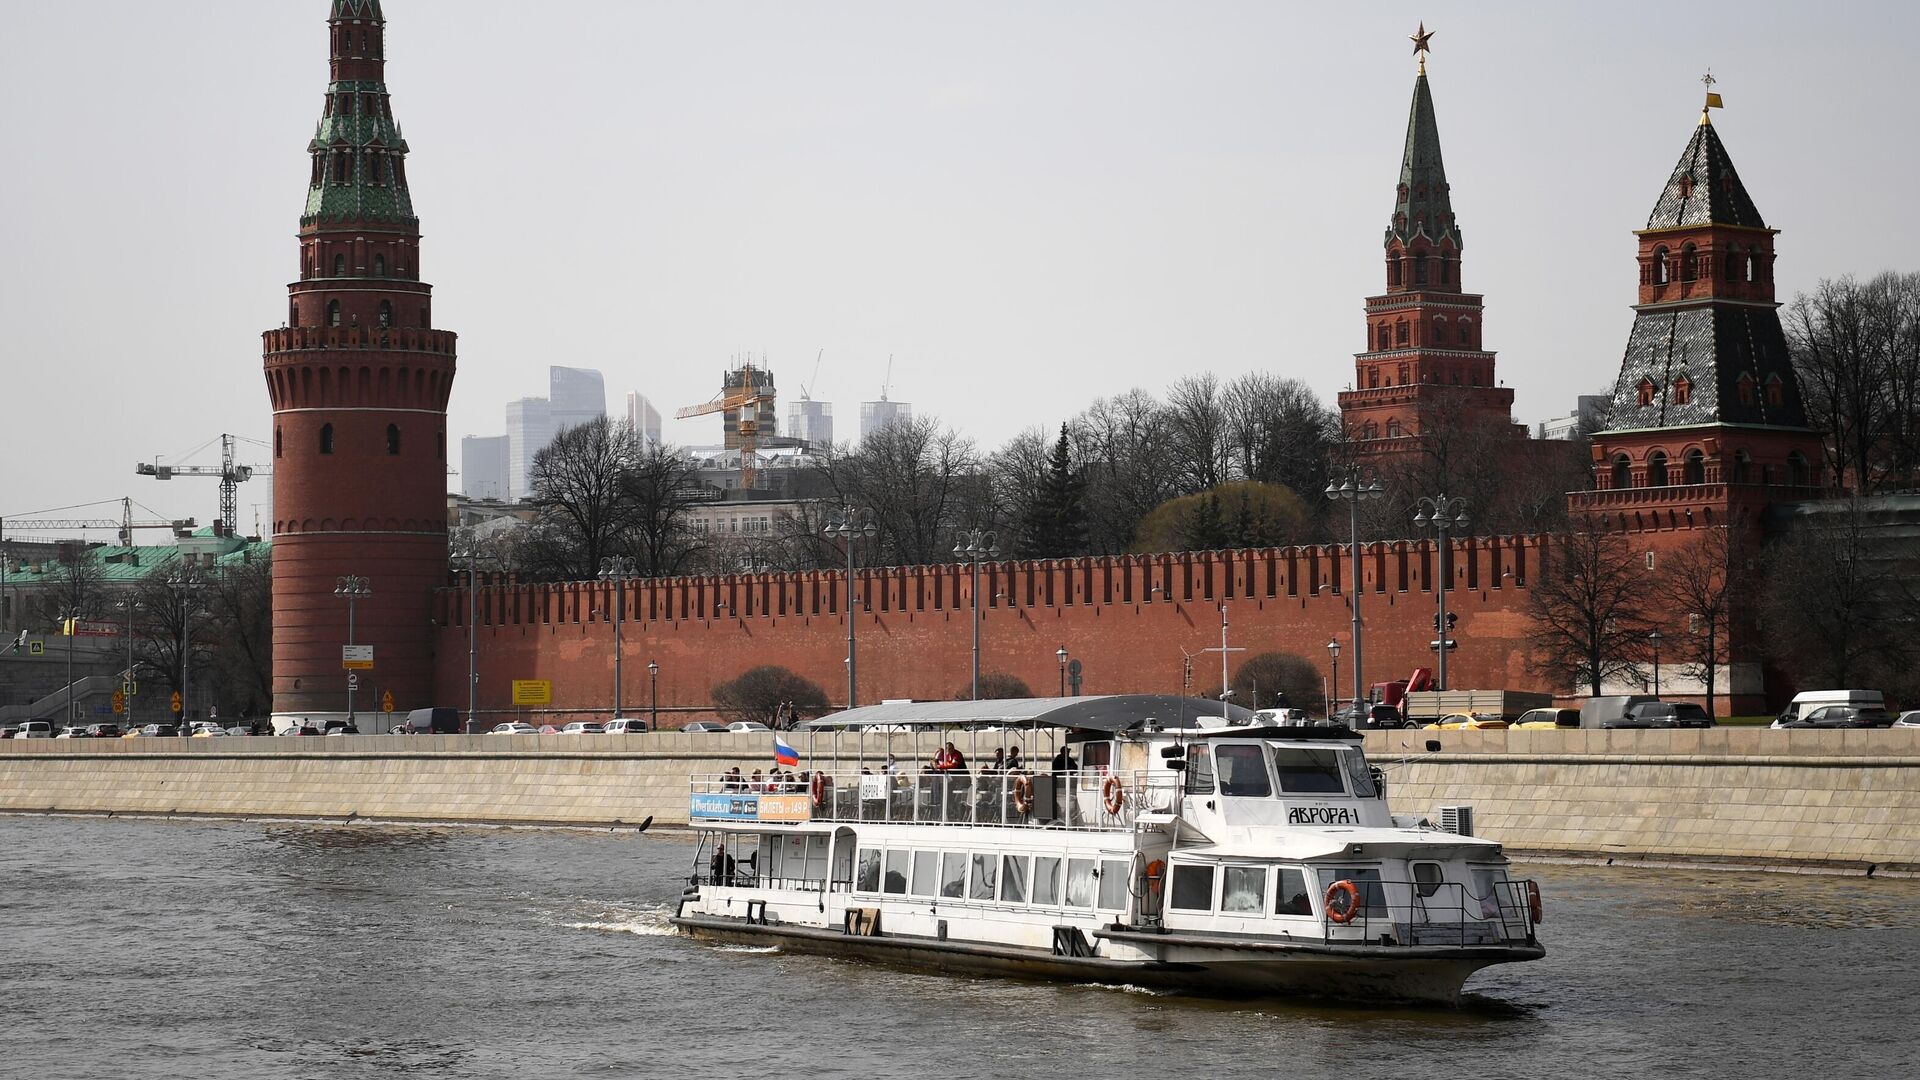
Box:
1526, 521, 1653, 696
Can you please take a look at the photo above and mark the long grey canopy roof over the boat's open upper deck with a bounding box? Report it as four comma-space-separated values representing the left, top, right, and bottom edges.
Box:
806, 694, 1254, 732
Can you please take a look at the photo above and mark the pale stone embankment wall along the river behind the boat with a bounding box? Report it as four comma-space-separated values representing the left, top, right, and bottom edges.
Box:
0, 728, 1920, 872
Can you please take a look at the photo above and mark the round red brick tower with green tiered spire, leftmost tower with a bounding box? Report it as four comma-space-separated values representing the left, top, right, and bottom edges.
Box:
265, 0, 453, 715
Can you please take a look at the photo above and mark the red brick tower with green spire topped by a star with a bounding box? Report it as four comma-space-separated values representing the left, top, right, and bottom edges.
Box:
1340, 39, 1526, 455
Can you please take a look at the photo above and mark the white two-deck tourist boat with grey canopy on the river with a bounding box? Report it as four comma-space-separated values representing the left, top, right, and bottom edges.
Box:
672, 696, 1546, 1003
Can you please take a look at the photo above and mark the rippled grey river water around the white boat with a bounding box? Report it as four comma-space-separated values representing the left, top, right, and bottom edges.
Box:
0, 817, 1920, 1080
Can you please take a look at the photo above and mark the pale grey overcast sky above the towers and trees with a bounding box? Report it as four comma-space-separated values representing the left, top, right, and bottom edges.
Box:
0, 0, 1920, 542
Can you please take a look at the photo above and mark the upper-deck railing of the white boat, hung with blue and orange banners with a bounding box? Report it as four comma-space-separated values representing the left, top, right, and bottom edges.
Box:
689, 769, 1181, 832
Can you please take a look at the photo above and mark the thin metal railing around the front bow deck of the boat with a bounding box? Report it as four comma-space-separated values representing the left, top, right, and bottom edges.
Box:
1321, 878, 1536, 945
